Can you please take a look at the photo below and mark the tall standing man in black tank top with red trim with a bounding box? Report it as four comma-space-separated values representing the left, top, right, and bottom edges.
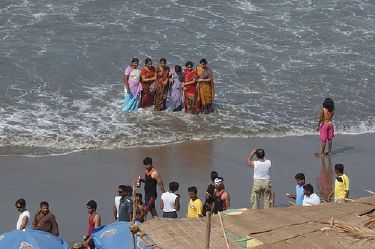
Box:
138, 157, 165, 217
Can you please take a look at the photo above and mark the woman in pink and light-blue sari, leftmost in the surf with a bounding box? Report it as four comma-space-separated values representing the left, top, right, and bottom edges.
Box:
122, 58, 142, 112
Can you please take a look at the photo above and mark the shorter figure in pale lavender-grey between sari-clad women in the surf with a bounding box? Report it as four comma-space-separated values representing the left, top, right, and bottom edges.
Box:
170, 65, 184, 112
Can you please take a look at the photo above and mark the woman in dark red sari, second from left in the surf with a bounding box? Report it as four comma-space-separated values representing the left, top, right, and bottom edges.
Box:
141, 58, 156, 108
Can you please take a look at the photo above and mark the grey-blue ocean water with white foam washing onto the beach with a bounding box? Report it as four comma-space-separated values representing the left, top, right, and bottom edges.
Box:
0, 0, 375, 155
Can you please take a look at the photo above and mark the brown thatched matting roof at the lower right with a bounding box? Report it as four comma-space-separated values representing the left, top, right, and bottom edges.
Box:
140, 196, 375, 249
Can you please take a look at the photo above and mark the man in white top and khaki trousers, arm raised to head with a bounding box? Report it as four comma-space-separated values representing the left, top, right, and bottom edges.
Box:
247, 148, 272, 209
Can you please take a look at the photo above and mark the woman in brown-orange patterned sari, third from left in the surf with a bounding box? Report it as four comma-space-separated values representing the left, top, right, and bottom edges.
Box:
155, 58, 169, 111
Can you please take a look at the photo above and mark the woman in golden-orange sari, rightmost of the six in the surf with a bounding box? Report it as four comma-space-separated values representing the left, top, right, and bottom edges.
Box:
196, 59, 214, 114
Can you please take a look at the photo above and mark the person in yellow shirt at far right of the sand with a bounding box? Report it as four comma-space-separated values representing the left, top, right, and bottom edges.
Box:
327, 163, 350, 203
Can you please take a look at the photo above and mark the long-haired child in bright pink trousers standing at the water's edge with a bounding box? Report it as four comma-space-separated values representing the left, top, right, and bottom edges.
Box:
316, 98, 335, 156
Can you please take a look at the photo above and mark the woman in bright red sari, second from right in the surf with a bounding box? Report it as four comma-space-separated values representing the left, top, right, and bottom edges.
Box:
184, 61, 198, 114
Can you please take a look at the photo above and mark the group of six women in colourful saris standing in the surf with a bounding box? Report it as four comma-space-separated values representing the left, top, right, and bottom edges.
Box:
122, 58, 214, 114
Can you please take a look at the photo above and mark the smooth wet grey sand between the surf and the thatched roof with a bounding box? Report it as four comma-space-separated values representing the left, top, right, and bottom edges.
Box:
0, 134, 375, 241
